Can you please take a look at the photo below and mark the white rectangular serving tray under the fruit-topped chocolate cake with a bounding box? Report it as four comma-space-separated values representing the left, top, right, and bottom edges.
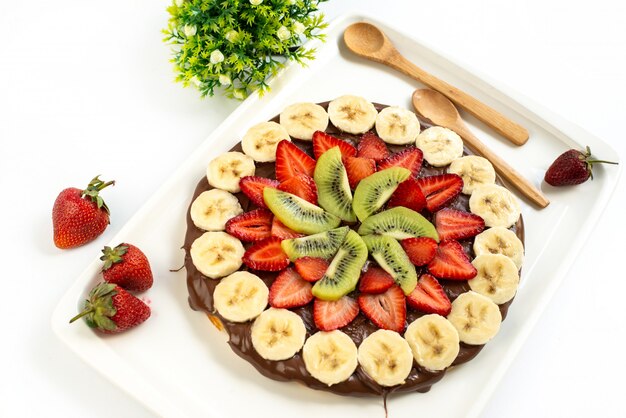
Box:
52, 15, 622, 418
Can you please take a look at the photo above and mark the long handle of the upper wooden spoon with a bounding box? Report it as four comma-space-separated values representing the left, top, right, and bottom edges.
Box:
382, 51, 528, 145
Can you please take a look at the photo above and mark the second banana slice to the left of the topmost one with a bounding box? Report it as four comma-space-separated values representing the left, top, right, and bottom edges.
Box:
241, 122, 291, 162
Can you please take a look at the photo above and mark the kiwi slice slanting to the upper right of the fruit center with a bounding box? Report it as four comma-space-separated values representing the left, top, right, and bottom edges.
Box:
352, 167, 411, 222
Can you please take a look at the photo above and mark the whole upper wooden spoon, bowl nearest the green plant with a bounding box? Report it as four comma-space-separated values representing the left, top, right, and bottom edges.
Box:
343, 22, 528, 145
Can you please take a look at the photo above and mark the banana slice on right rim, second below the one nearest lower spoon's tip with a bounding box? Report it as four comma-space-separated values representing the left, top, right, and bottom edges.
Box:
467, 254, 519, 305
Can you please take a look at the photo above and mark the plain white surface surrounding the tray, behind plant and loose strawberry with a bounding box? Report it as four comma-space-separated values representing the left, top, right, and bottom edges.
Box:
0, 0, 626, 418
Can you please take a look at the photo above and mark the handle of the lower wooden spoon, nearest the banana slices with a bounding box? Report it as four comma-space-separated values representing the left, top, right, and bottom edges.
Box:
449, 124, 550, 208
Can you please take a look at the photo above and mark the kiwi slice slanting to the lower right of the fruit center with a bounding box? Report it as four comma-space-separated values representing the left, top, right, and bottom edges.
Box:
363, 235, 417, 295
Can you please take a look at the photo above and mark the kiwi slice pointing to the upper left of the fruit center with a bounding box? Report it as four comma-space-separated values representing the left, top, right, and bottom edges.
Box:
263, 187, 341, 235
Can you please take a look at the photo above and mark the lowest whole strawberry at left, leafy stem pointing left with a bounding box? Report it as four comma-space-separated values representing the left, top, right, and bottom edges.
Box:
70, 283, 150, 334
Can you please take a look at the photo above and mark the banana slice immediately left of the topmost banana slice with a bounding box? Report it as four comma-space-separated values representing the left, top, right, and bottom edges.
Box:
280, 103, 328, 141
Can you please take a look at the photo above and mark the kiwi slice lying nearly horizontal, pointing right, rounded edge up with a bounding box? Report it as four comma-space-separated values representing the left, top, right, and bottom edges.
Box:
359, 206, 439, 241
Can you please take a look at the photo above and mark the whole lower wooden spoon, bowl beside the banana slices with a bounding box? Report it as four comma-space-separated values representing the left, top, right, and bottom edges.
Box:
413, 89, 550, 208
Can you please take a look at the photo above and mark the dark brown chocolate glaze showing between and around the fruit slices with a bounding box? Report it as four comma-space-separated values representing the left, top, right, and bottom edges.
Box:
184, 102, 524, 397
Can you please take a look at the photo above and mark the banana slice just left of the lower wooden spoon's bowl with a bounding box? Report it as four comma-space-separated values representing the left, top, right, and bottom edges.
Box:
376, 106, 420, 145
